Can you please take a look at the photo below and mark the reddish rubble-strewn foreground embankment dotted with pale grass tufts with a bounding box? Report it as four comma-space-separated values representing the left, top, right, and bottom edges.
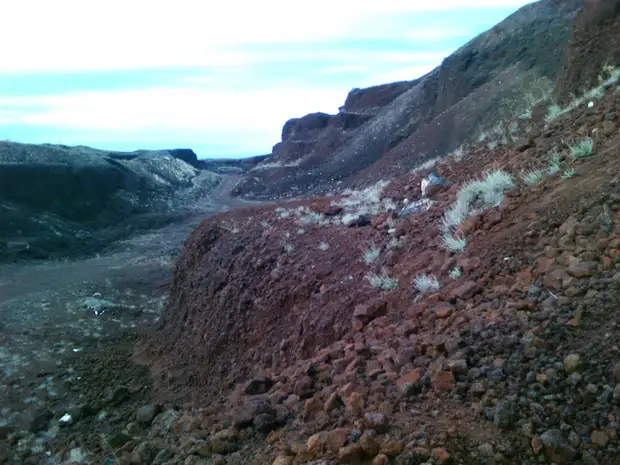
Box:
134, 1, 620, 465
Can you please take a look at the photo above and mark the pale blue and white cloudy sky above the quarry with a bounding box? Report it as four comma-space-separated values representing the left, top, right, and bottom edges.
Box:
0, 0, 531, 157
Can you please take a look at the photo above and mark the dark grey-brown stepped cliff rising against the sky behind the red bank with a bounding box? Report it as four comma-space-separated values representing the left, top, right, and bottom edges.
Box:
235, 0, 583, 199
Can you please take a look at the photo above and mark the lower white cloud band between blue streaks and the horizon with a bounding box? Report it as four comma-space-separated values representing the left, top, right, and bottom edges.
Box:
0, 87, 343, 133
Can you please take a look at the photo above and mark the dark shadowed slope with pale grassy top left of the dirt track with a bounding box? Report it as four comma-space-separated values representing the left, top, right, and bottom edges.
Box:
0, 142, 219, 260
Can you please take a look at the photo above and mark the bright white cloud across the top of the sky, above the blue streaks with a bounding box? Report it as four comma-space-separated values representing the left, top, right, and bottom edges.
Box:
0, 0, 527, 73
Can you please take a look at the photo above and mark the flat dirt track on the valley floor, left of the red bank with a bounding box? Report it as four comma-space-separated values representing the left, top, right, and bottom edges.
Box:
0, 176, 264, 464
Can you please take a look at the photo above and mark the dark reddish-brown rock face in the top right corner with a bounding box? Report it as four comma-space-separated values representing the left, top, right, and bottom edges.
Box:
556, 0, 620, 99
